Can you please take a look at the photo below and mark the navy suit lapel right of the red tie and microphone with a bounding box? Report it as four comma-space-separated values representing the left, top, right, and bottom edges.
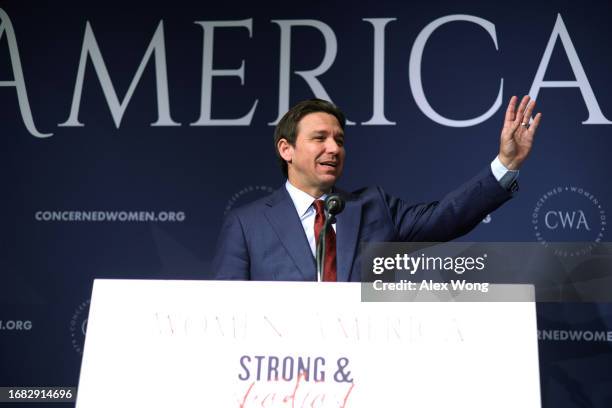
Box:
336, 190, 361, 282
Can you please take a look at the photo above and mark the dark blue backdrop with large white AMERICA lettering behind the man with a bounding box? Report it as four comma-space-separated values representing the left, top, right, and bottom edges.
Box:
0, 0, 612, 407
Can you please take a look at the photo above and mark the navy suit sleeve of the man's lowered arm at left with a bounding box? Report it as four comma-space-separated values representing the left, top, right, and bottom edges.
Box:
212, 213, 251, 280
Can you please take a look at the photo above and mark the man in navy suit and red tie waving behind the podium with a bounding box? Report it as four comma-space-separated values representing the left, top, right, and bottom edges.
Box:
212, 96, 541, 281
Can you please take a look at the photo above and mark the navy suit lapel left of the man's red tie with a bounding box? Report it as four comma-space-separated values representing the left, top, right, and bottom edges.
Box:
264, 186, 316, 281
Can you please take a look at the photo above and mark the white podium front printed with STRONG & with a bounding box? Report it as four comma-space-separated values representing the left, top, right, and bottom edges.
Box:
76, 280, 540, 408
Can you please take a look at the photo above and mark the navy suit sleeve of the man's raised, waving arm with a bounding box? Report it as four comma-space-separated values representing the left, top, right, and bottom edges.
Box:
381, 168, 512, 242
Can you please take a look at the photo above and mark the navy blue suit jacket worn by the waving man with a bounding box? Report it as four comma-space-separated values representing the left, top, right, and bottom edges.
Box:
212, 168, 512, 281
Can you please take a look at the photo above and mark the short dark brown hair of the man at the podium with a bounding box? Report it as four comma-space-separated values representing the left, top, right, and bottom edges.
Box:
274, 98, 346, 177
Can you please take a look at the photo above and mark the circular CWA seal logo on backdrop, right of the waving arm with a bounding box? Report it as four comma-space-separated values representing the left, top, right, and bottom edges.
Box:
531, 186, 606, 256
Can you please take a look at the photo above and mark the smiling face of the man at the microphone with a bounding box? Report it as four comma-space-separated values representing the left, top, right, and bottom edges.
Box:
279, 112, 345, 197
